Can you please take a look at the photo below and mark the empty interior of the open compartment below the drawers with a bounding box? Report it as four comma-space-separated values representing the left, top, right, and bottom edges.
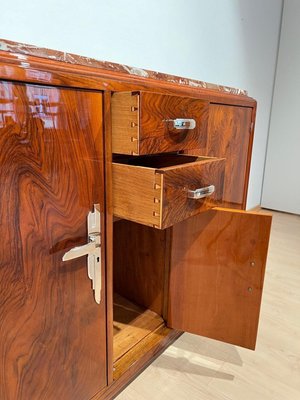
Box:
113, 220, 169, 379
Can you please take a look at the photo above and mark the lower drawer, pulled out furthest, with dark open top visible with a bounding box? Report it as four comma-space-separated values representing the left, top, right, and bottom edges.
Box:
112, 154, 225, 229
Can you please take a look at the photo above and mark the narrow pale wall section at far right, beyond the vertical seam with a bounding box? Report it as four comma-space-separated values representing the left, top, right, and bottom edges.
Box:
262, 0, 300, 214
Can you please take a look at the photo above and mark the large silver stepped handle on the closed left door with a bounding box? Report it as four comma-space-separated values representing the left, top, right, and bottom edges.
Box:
62, 204, 101, 304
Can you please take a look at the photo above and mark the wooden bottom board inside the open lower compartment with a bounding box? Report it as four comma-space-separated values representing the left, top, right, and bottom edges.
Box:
113, 293, 164, 364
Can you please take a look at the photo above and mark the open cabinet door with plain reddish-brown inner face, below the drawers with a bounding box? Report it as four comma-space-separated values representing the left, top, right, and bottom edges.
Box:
167, 209, 272, 349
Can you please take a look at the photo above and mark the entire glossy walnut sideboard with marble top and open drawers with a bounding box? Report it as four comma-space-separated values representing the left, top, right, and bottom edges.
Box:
0, 40, 271, 400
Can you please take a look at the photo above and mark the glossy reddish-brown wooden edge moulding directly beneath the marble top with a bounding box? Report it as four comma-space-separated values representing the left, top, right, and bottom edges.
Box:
0, 51, 256, 107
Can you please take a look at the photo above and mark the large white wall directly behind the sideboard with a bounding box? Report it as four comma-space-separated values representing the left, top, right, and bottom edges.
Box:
0, 0, 282, 208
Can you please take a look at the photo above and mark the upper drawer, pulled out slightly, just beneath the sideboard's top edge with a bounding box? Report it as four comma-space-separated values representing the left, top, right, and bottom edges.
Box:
112, 91, 209, 155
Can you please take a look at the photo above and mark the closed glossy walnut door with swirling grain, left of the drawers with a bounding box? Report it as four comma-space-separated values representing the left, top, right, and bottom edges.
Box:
0, 82, 106, 400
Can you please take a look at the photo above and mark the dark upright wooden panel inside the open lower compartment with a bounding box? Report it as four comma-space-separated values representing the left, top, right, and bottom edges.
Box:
114, 220, 167, 315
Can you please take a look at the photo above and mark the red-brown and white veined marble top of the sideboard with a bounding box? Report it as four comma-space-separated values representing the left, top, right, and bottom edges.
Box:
0, 39, 248, 96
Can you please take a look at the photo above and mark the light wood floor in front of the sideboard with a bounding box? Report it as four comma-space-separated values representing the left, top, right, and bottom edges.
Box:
117, 213, 300, 400
